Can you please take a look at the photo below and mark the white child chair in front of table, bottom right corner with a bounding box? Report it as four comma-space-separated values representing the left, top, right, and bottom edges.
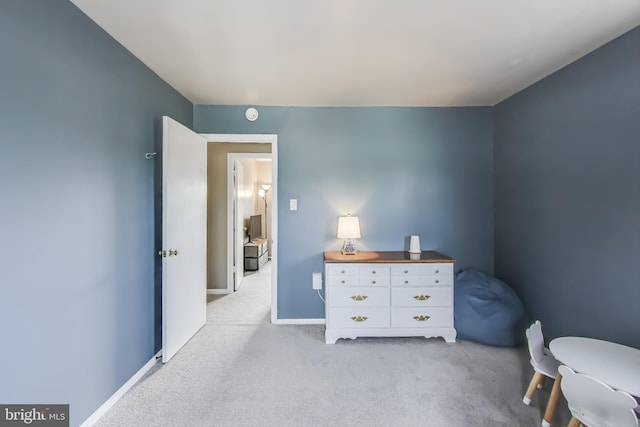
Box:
559, 365, 638, 427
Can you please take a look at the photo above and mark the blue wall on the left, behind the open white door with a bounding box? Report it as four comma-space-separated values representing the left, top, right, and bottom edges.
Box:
0, 0, 193, 425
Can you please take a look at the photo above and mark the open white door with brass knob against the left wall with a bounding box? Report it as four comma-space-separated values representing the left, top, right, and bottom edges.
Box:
161, 116, 207, 363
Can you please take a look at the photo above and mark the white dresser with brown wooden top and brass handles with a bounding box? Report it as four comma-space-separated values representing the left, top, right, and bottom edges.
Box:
324, 251, 456, 344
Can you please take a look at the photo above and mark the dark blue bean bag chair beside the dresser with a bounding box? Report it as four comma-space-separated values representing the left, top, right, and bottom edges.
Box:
454, 270, 527, 347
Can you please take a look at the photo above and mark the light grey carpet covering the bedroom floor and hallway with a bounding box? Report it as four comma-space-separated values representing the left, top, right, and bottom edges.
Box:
97, 267, 569, 427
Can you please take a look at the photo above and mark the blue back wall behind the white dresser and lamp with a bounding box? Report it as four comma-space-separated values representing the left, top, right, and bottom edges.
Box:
194, 105, 493, 319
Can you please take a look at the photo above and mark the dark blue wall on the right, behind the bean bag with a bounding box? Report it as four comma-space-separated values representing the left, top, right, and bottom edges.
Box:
494, 28, 640, 347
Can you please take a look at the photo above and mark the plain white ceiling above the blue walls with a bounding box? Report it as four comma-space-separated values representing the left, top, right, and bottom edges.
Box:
72, 0, 640, 106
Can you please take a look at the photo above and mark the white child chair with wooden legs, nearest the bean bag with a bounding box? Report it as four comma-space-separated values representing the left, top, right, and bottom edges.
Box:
522, 320, 560, 405
